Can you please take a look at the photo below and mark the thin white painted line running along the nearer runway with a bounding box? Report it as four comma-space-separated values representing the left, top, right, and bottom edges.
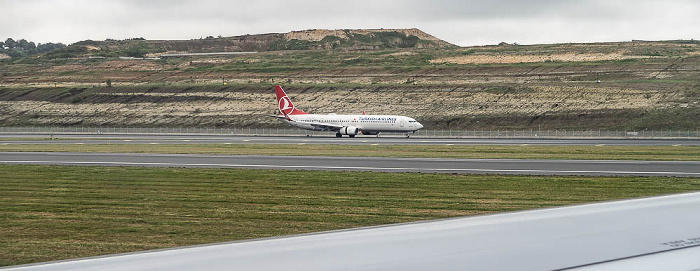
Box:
0, 160, 700, 176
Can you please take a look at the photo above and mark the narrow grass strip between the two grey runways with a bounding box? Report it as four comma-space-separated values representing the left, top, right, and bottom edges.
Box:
0, 144, 700, 161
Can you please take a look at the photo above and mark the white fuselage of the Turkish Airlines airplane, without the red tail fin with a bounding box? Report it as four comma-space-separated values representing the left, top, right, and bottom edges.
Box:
282, 114, 423, 133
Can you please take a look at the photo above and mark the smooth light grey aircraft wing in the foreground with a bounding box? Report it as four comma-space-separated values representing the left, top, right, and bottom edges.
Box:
8, 193, 700, 271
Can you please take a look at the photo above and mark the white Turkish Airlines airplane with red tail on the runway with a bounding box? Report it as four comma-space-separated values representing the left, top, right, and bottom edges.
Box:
271, 85, 423, 138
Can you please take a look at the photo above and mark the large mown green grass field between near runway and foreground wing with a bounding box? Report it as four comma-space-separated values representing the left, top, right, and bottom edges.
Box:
0, 165, 700, 266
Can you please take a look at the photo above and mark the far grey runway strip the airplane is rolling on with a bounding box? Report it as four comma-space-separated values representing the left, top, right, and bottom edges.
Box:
0, 134, 700, 146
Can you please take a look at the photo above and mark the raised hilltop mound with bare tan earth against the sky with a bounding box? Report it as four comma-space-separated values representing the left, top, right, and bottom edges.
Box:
37, 28, 455, 59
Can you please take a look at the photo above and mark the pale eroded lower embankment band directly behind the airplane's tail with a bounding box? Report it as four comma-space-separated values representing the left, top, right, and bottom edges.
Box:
0, 85, 698, 129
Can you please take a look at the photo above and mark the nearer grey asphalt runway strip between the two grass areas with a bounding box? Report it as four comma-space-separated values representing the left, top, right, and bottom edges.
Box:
0, 152, 700, 177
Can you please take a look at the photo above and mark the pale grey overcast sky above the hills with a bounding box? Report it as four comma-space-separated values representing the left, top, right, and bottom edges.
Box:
0, 0, 700, 46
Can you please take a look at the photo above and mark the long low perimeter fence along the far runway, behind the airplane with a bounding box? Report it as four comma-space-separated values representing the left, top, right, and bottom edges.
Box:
0, 127, 700, 139
